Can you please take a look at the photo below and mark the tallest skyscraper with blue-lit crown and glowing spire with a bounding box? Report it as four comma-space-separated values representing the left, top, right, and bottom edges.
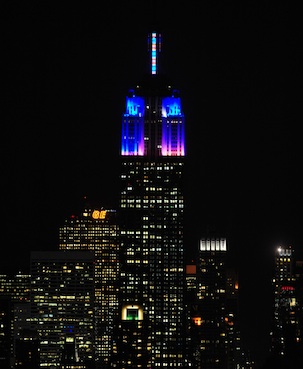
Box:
115, 33, 187, 369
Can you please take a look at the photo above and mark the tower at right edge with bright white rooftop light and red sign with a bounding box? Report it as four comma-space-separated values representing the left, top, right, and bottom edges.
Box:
271, 246, 303, 368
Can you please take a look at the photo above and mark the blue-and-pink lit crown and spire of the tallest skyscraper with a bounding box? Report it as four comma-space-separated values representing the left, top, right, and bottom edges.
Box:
121, 33, 185, 156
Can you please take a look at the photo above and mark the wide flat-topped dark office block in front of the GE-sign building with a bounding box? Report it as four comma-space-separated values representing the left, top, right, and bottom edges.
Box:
30, 251, 95, 368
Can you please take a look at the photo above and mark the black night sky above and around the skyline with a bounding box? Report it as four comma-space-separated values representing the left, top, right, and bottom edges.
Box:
0, 1, 303, 366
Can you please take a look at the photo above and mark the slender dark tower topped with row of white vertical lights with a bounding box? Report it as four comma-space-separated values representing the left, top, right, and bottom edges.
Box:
191, 238, 233, 369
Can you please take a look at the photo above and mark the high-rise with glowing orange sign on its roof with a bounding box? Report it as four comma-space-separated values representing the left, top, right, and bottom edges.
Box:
59, 204, 119, 369
